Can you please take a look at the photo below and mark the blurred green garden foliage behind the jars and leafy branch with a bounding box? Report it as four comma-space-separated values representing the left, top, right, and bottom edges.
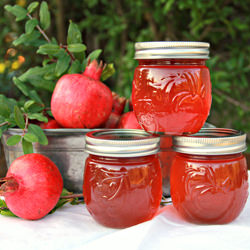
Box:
0, 0, 250, 149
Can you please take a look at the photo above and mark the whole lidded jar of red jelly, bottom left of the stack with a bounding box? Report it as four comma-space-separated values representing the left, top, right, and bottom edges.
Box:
83, 129, 162, 228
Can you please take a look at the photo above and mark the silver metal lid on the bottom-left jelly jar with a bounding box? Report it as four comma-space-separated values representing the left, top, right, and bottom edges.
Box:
85, 129, 160, 157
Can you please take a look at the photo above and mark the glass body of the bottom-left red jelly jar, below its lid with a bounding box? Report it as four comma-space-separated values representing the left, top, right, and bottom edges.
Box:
83, 155, 162, 228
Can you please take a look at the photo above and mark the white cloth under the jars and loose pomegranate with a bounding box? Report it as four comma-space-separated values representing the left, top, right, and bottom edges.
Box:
0, 176, 250, 250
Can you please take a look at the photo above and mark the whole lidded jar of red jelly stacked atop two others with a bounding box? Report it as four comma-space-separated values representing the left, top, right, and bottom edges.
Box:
132, 42, 212, 135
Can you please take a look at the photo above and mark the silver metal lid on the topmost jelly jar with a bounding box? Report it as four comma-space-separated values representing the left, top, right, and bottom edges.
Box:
134, 41, 210, 59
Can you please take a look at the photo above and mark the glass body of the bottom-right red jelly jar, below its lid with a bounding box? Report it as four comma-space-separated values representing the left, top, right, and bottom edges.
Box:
170, 153, 248, 224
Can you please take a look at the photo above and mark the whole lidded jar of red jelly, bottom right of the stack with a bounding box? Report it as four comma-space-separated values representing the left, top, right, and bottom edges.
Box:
170, 128, 248, 224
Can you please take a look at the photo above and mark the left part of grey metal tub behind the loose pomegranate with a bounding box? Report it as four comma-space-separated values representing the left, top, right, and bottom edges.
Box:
2, 128, 91, 193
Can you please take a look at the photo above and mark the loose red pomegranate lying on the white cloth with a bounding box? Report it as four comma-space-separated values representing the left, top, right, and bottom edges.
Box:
0, 153, 63, 220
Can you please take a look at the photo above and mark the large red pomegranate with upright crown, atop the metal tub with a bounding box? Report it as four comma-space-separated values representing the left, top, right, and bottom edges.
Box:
51, 60, 113, 128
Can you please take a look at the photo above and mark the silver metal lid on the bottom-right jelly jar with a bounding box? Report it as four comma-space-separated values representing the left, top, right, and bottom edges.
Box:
173, 128, 247, 155
